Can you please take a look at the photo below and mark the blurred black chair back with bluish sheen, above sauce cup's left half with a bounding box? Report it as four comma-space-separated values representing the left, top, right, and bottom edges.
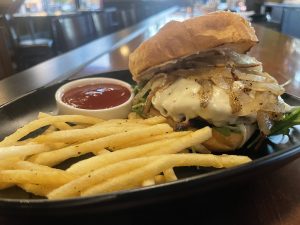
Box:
55, 14, 95, 52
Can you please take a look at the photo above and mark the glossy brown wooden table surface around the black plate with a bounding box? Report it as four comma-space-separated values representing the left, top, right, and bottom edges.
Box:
0, 7, 300, 225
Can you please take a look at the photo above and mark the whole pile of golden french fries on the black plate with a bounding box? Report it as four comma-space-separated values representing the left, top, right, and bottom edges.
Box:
0, 113, 251, 199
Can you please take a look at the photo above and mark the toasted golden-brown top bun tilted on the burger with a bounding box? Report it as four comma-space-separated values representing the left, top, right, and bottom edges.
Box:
129, 12, 258, 82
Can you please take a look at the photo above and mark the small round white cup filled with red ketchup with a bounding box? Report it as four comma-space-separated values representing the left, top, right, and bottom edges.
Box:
55, 77, 134, 119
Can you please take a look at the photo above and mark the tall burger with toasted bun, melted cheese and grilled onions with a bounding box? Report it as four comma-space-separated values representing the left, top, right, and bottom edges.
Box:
129, 12, 293, 152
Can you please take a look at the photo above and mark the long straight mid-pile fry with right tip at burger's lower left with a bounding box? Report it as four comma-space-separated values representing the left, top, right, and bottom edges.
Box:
28, 124, 172, 166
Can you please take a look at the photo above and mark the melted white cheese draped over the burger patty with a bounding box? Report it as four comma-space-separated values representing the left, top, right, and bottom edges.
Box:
152, 78, 235, 126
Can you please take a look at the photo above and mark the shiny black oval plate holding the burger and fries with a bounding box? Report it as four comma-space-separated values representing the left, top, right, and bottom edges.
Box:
0, 70, 300, 215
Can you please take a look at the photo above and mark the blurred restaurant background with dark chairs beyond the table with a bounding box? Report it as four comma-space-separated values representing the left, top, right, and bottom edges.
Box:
0, 0, 300, 74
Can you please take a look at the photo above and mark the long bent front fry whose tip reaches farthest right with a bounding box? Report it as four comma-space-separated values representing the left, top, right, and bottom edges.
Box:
81, 154, 251, 196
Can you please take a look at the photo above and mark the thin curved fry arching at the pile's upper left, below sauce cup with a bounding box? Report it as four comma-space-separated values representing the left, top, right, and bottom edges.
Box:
0, 115, 102, 147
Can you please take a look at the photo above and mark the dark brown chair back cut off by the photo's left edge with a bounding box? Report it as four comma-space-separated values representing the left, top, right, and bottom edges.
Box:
0, 27, 13, 79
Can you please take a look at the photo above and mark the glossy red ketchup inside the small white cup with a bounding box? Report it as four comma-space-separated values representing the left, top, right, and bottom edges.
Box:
62, 83, 131, 109
